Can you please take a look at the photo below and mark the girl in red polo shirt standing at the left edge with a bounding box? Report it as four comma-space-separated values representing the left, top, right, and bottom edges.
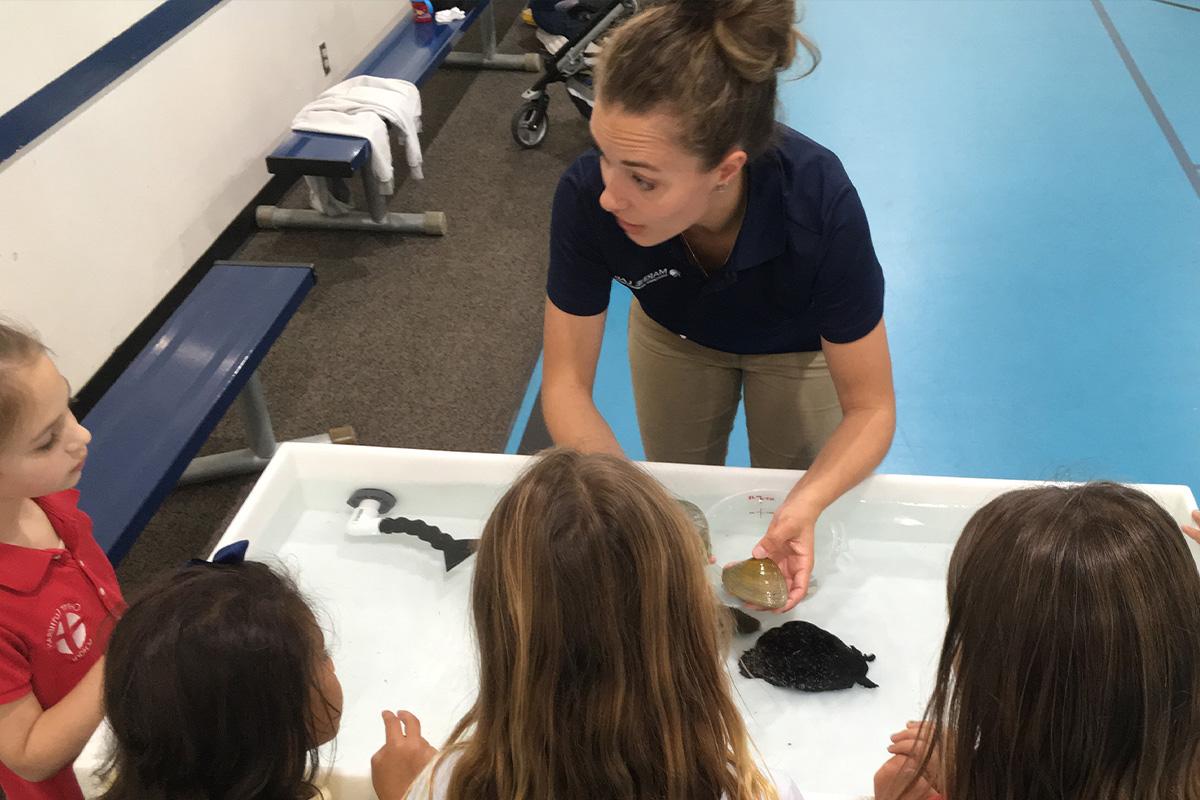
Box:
0, 323, 124, 800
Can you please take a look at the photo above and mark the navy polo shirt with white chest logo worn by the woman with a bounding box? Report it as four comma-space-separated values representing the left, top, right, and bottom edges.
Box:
546, 125, 883, 354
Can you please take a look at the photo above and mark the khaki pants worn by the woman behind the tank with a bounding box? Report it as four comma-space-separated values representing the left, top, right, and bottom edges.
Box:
629, 300, 841, 469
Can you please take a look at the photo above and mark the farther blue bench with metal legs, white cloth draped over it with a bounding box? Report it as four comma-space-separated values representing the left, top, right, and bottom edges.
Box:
254, 0, 541, 235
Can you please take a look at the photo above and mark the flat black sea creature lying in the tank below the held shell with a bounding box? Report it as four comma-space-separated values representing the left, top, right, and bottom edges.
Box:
738, 620, 878, 692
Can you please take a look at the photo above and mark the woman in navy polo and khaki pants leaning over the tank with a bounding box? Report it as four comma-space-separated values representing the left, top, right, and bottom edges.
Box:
541, 0, 895, 610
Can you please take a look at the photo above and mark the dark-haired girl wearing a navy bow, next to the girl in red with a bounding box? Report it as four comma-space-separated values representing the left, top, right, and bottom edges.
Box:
102, 554, 342, 800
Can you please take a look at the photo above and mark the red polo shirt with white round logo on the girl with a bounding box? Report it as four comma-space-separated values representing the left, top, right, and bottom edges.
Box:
0, 489, 125, 800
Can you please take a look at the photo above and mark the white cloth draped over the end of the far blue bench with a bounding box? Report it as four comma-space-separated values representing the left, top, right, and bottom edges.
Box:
292, 76, 424, 194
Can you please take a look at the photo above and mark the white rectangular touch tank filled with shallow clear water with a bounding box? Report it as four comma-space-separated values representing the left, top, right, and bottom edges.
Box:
80, 445, 1194, 799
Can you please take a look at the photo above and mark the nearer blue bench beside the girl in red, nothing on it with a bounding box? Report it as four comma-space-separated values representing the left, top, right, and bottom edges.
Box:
79, 261, 354, 564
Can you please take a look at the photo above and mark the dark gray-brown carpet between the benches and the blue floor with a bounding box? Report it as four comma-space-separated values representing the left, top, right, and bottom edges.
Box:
119, 0, 588, 594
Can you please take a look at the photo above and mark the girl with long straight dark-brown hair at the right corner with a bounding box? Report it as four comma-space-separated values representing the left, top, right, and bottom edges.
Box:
875, 483, 1200, 800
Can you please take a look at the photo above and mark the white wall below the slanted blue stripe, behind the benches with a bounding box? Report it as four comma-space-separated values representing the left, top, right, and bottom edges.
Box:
0, 0, 410, 386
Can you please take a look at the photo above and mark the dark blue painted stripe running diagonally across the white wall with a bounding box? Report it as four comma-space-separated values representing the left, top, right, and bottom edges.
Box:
0, 0, 223, 162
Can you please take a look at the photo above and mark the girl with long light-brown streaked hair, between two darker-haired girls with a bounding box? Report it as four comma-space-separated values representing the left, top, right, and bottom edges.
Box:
372, 450, 779, 800
